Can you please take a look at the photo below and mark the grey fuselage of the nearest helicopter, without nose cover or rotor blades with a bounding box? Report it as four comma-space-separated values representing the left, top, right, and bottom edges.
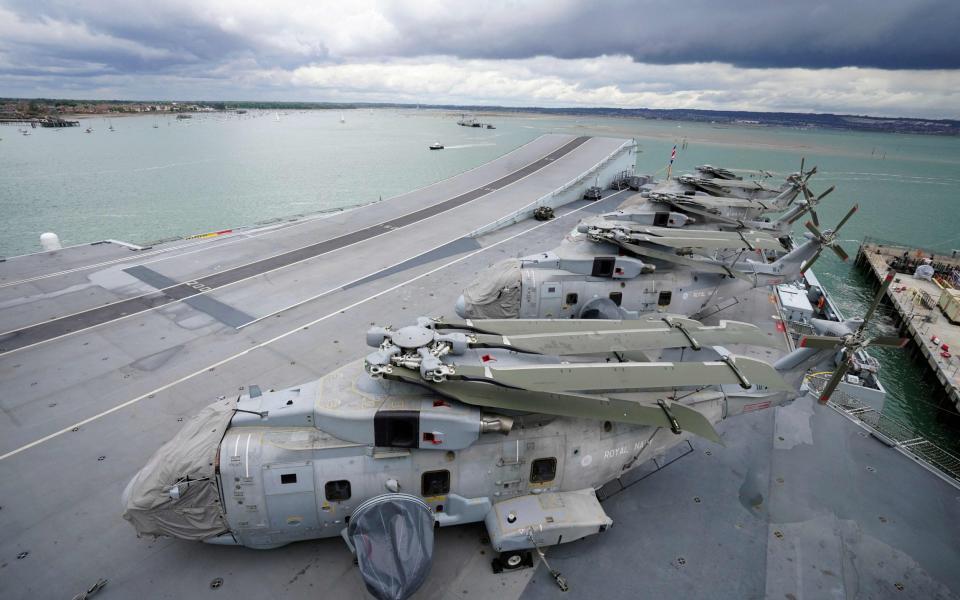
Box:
206, 368, 796, 549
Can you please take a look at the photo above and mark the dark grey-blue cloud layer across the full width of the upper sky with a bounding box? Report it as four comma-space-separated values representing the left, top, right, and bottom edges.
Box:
0, 0, 960, 73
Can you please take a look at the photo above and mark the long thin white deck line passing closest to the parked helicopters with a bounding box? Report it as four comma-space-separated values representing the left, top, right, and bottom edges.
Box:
0, 197, 608, 461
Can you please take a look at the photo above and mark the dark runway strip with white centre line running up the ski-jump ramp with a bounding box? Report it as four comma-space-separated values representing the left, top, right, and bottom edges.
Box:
0, 136, 590, 356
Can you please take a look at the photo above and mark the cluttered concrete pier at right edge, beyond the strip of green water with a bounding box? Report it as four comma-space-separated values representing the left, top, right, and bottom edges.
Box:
855, 238, 960, 410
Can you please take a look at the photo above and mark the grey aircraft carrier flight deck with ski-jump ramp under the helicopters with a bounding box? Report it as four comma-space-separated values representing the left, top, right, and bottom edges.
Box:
0, 135, 960, 600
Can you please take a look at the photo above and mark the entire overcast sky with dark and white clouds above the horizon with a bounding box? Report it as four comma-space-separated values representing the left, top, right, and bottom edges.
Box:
0, 0, 960, 118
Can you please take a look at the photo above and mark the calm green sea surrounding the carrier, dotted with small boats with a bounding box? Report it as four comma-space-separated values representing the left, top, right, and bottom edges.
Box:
0, 110, 960, 452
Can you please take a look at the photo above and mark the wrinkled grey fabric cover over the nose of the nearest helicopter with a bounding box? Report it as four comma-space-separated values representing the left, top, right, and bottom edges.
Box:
123, 400, 237, 540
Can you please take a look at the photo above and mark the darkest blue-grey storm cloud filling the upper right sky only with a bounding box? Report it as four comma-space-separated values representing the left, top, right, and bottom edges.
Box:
389, 0, 960, 69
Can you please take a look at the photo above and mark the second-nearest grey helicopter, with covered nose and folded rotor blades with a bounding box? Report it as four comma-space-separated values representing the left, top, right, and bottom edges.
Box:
455, 200, 857, 319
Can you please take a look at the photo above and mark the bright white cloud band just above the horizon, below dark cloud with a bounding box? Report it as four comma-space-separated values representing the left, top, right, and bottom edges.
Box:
278, 56, 960, 117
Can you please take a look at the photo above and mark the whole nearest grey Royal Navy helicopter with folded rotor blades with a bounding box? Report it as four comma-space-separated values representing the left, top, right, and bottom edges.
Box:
123, 278, 901, 599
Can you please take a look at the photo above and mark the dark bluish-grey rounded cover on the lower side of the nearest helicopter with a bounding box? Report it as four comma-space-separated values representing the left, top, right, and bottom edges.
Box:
347, 494, 433, 600
